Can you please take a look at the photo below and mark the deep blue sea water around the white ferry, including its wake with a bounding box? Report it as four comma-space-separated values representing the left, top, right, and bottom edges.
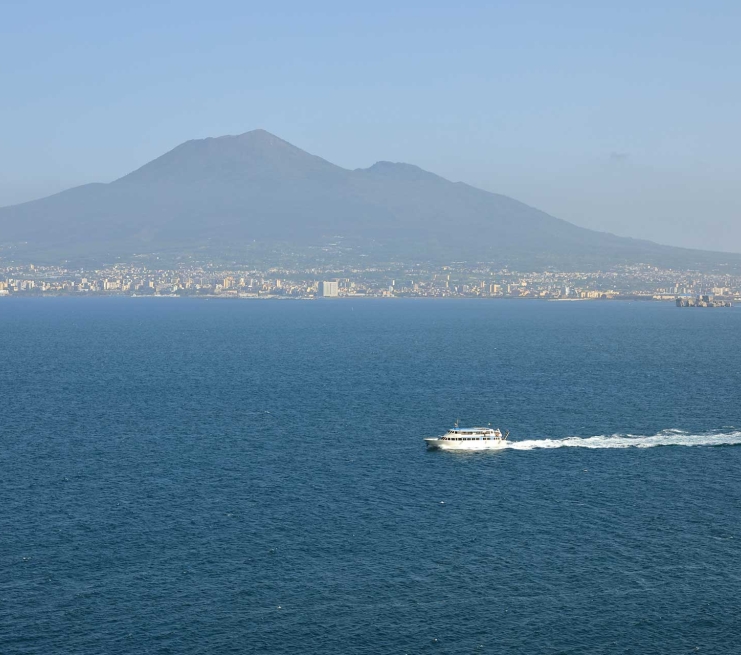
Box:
0, 298, 741, 655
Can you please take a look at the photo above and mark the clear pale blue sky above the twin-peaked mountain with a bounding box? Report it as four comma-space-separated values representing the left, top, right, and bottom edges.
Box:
0, 0, 741, 252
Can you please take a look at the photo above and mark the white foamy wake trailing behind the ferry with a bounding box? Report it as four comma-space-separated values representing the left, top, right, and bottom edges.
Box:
507, 430, 741, 450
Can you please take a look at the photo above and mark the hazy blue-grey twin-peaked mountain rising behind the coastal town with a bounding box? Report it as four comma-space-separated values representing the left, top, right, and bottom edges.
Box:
0, 130, 741, 269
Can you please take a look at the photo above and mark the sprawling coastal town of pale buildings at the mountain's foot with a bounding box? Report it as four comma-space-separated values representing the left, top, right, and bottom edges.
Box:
0, 261, 741, 306
